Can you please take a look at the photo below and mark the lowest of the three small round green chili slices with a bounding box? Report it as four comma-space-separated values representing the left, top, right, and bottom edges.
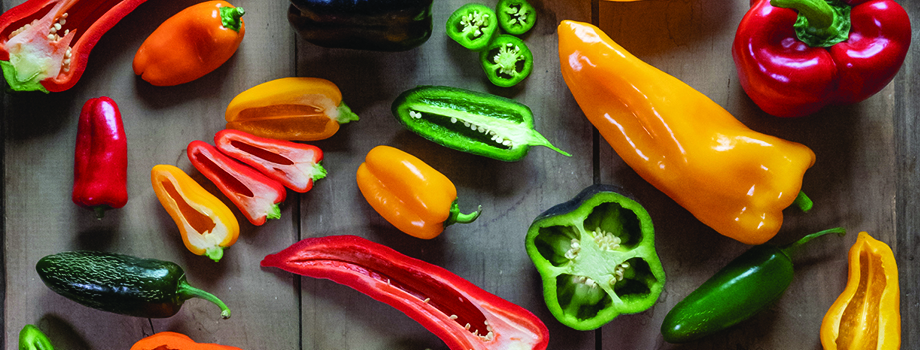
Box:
479, 34, 533, 87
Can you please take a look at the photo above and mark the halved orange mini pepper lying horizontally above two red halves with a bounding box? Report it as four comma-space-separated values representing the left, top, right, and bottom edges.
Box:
225, 77, 358, 141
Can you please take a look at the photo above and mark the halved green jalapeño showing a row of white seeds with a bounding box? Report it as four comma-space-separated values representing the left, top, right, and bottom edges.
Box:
392, 86, 570, 162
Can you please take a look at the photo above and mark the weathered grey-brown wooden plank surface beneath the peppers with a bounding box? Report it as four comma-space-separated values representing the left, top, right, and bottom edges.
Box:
2, 0, 920, 350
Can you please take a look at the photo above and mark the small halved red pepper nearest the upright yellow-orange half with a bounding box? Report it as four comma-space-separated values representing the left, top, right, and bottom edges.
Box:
187, 141, 287, 226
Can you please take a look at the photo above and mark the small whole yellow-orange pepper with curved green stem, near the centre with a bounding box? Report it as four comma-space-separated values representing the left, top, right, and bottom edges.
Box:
357, 146, 482, 239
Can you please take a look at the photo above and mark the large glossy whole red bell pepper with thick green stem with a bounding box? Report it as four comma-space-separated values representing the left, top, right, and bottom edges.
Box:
732, 0, 911, 117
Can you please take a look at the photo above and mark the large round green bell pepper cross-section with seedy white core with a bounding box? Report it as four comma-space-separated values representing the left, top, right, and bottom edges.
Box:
524, 184, 665, 331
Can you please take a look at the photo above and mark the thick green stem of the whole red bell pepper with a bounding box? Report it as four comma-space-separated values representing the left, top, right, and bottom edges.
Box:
770, 0, 850, 47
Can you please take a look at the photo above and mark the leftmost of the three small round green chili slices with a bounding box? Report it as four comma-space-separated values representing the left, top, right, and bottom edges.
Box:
447, 3, 498, 51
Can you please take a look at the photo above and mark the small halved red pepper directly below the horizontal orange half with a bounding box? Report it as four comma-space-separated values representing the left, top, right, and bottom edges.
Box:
214, 129, 326, 193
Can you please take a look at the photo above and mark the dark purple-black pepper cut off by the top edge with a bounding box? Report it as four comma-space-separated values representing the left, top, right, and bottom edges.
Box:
288, 0, 433, 51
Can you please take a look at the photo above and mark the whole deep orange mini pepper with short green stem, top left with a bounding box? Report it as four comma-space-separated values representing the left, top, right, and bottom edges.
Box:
132, 1, 246, 86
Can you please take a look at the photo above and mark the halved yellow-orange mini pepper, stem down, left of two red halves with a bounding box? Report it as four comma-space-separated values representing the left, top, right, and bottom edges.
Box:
150, 164, 240, 261
